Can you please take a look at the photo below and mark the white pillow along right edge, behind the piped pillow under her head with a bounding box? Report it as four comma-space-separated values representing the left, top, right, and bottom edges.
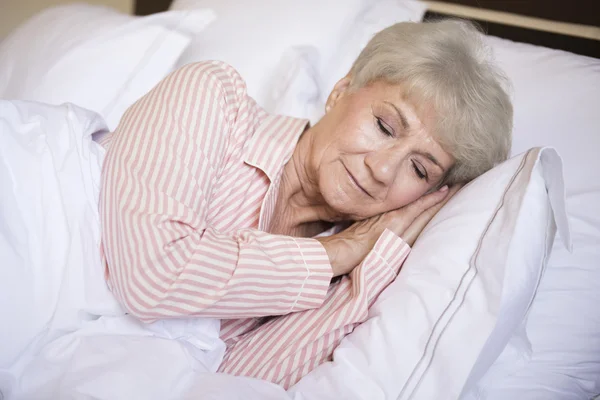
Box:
464, 37, 600, 400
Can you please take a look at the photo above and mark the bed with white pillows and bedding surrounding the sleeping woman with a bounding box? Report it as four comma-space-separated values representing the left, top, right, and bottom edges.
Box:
0, 0, 600, 400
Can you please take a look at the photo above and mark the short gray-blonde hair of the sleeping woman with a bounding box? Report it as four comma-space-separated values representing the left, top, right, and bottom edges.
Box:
350, 20, 513, 184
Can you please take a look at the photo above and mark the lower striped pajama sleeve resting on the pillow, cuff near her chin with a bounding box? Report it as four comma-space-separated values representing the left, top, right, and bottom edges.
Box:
219, 230, 410, 389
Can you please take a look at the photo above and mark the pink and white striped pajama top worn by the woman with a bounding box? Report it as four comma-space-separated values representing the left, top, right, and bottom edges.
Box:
100, 61, 409, 388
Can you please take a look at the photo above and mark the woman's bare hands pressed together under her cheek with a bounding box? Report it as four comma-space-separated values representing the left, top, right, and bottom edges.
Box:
317, 185, 460, 276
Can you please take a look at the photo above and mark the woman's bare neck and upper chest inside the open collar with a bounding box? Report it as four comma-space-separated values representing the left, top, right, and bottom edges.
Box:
270, 129, 343, 236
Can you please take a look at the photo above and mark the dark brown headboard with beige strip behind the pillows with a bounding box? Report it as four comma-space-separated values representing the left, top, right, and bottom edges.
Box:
135, 0, 600, 58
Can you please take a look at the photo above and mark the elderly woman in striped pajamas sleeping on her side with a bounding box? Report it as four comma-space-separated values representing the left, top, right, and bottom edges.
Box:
101, 21, 512, 387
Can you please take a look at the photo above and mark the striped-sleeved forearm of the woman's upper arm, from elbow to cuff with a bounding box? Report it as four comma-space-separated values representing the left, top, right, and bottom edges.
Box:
109, 227, 332, 322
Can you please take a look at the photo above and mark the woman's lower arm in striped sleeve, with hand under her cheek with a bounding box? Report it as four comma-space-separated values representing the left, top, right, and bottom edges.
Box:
219, 186, 458, 389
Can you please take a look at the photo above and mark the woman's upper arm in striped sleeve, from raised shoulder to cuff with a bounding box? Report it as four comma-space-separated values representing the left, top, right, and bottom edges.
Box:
100, 62, 332, 322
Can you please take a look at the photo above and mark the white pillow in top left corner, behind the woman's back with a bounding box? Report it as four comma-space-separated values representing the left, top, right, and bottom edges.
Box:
0, 4, 214, 130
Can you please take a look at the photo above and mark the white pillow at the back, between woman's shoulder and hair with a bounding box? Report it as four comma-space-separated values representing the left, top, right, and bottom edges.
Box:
171, 0, 366, 112
